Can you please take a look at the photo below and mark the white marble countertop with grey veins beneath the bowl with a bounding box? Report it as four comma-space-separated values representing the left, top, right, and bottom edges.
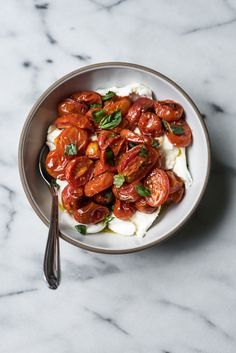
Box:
0, 0, 236, 353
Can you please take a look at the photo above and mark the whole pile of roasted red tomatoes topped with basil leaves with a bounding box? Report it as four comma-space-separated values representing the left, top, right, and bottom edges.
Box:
46, 91, 192, 224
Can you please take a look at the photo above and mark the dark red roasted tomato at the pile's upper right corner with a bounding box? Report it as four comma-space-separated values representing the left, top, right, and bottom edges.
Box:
154, 99, 184, 121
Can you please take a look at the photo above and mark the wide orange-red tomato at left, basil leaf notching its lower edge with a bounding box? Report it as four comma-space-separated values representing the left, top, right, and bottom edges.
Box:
54, 126, 89, 156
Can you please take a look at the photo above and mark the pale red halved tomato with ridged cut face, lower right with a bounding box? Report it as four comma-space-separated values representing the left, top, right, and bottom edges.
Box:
144, 168, 170, 207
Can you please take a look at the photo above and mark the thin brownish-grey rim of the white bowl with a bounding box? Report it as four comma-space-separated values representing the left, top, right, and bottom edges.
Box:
18, 61, 211, 255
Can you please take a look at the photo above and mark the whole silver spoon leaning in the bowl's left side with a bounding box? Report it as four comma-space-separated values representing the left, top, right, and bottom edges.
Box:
39, 145, 61, 289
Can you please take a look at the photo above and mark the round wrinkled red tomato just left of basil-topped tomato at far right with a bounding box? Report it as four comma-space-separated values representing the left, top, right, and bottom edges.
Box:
138, 112, 163, 137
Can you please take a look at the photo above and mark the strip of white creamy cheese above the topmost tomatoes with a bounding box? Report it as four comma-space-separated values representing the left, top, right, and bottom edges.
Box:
97, 82, 152, 98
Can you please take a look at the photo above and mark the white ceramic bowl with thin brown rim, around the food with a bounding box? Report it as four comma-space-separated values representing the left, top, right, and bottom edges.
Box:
19, 62, 210, 254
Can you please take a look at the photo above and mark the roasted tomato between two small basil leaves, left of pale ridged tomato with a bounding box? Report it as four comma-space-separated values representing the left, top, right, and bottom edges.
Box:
112, 181, 141, 203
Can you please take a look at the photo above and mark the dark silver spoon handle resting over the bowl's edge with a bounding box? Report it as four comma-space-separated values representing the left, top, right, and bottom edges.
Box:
43, 187, 61, 289
